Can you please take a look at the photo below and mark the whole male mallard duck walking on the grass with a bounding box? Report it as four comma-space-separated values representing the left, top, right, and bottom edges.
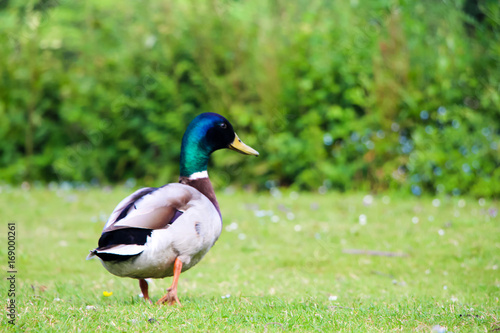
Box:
87, 113, 259, 305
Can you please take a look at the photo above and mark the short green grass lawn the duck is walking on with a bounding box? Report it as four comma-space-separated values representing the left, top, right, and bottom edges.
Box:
0, 186, 500, 332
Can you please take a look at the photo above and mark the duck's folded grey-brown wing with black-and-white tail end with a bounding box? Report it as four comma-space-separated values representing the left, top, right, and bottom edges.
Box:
87, 184, 196, 261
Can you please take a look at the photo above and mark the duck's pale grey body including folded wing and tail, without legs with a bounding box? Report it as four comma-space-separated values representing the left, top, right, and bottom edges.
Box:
89, 184, 222, 279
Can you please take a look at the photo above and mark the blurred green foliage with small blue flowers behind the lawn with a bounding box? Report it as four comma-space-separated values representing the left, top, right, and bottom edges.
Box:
0, 0, 500, 197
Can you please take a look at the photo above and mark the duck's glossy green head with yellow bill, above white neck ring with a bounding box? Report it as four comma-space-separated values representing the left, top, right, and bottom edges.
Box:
180, 113, 259, 177
